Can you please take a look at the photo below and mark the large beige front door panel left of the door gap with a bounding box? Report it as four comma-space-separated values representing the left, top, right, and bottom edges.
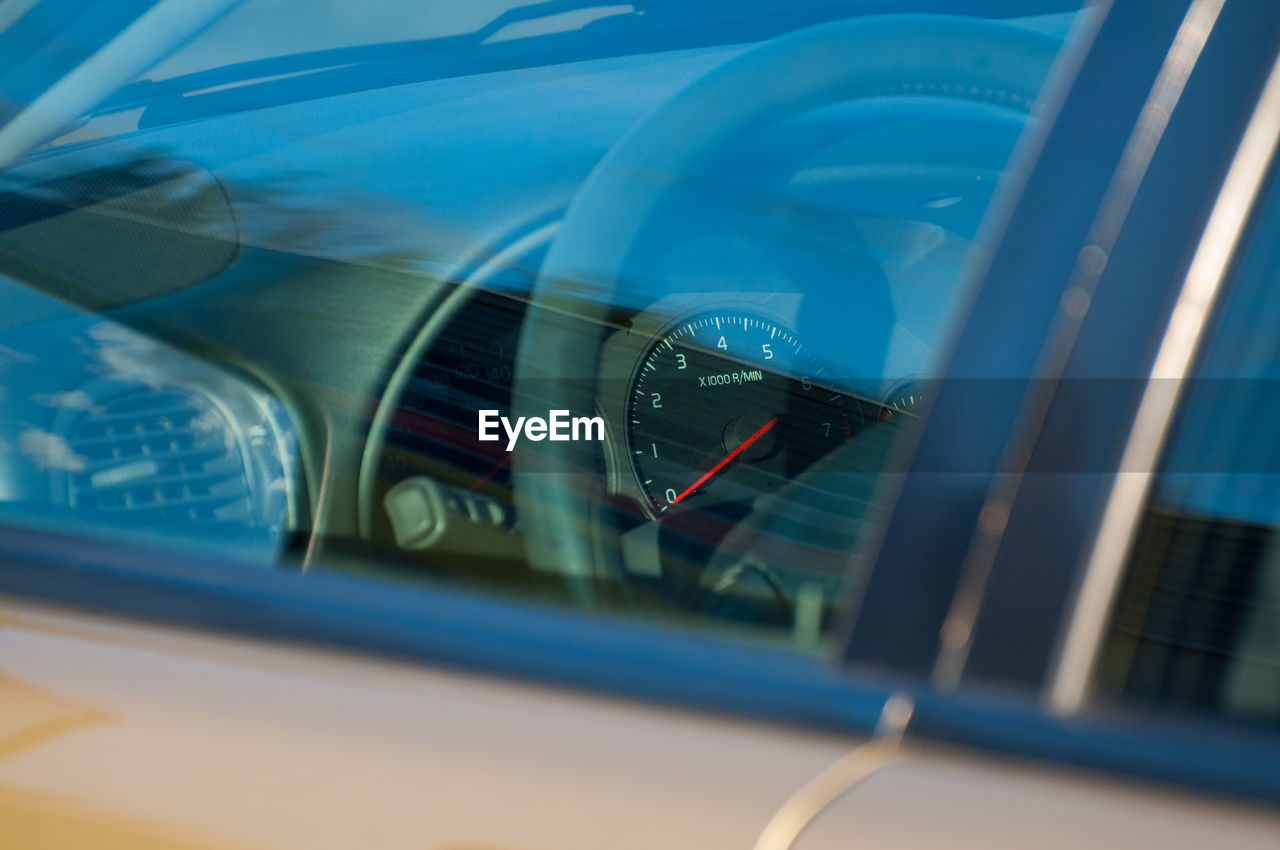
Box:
0, 600, 858, 850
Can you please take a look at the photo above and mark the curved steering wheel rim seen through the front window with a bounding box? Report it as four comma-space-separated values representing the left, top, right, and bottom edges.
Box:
513, 15, 1061, 603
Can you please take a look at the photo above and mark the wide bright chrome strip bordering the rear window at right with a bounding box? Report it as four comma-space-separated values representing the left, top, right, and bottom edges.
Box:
1046, 43, 1280, 714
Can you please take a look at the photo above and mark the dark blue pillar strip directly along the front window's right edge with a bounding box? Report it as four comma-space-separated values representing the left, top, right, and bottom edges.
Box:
841, 0, 1196, 677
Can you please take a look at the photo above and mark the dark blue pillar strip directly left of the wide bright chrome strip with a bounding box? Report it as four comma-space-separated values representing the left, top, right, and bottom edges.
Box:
933, 0, 1280, 696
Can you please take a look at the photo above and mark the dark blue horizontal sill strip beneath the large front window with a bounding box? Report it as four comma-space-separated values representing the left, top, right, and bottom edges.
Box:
0, 524, 891, 734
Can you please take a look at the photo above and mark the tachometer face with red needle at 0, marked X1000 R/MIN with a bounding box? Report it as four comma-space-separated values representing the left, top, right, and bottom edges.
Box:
627, 311, 877, 513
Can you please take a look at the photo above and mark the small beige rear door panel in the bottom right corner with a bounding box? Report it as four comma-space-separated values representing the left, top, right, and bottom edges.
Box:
792, 749, 1280, 850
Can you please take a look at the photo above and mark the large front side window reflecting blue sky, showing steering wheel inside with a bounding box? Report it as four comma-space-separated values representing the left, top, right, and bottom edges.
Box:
0, 0, 1076, 650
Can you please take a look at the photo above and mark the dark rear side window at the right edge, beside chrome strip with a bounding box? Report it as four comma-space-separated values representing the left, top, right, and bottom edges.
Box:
1098, 163, 1280, 726
